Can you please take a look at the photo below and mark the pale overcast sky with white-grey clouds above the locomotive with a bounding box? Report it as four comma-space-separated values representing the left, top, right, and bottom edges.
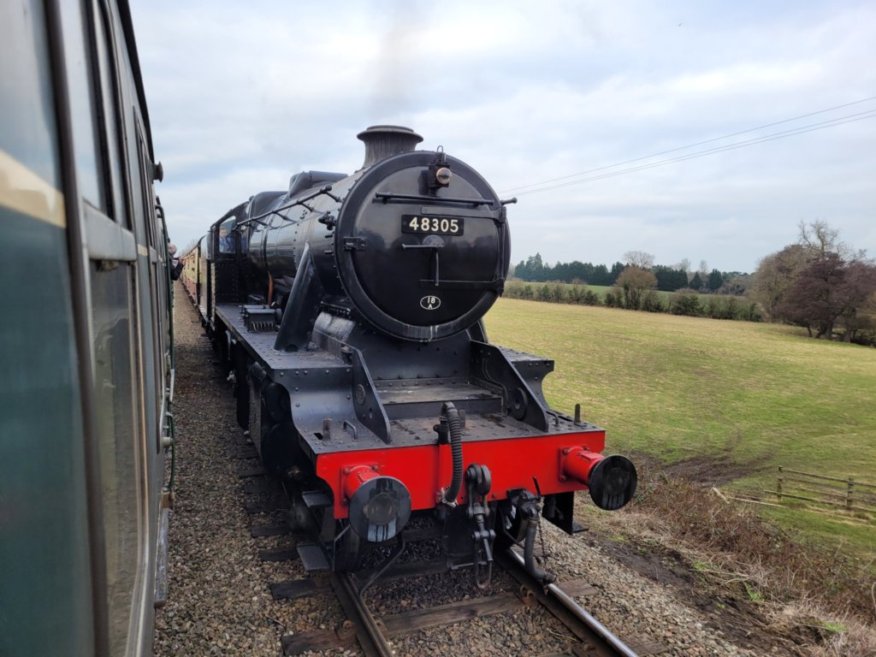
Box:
132, 0, 876, 271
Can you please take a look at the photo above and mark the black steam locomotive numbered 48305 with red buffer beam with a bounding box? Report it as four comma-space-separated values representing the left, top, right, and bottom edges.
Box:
182, 126, 636, 585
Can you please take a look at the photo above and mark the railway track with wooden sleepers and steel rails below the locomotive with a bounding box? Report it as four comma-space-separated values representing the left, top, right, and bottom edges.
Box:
234, 444, 663, 657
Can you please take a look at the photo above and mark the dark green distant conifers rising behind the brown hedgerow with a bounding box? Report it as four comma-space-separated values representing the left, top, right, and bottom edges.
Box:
514, 253, 748, 294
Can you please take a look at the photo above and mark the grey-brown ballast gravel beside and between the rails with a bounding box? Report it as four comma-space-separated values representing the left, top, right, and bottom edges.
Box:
154, 286, 790, 657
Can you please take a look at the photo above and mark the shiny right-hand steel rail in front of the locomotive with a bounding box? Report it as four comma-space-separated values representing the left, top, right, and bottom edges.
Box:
496, 549, 638, 657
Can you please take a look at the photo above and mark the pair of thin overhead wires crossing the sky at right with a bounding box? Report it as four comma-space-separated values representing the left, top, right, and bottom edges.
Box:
501, 96, 876, 195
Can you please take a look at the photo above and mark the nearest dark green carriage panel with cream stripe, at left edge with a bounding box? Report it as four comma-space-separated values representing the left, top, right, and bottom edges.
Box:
0, 0, 94, 657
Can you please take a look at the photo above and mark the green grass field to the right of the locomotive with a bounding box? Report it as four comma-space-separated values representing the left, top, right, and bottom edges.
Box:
486, 299, 876, 551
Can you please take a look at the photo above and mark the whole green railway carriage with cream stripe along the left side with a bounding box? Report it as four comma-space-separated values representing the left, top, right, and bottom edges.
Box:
0, 0, 173, 657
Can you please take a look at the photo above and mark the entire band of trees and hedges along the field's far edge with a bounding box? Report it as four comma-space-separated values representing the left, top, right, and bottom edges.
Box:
505, 221, 876, 347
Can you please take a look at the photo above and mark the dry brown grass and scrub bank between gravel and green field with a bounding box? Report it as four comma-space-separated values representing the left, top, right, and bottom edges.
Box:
582, 455, 876, 657
